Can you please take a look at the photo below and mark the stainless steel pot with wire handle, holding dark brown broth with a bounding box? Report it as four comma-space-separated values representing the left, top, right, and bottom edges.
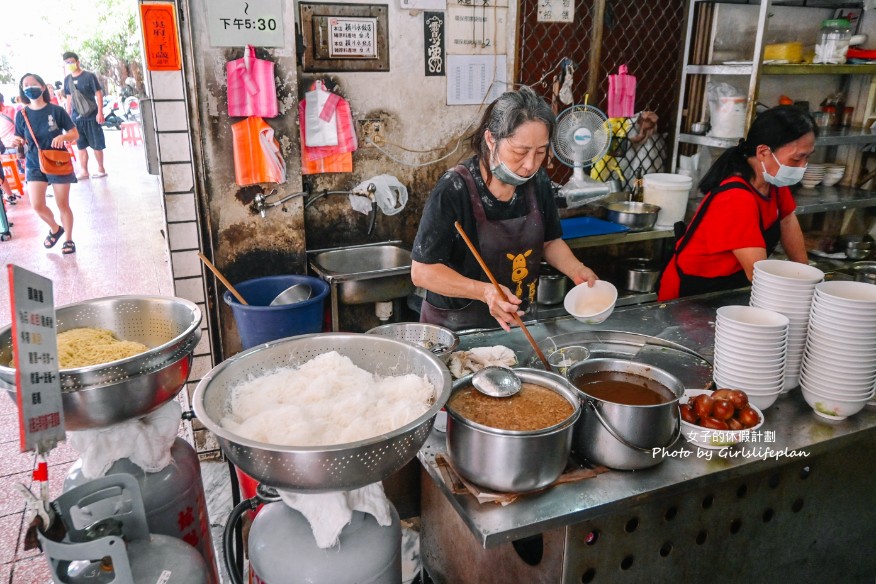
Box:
568, 359, 684, 470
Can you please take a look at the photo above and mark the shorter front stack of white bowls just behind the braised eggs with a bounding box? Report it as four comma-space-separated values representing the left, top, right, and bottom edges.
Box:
714, 306, 792, 410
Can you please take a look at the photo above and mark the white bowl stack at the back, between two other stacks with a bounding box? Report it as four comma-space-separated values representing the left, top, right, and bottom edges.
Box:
750, 260, 824, 391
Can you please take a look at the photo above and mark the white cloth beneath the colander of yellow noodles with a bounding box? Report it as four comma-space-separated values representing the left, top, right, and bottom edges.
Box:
67, 399, 182, 479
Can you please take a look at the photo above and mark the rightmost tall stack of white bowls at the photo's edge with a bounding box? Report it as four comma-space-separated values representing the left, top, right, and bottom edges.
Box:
800, 281, 876, 420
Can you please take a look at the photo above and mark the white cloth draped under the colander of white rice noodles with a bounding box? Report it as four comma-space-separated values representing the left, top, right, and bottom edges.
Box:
277, 482, 392, 549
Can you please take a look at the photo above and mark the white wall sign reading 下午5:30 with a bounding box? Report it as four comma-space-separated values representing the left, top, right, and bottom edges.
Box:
206, 0, 285, 47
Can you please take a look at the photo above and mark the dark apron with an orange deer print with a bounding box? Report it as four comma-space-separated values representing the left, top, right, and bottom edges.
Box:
420, 164, 544, 330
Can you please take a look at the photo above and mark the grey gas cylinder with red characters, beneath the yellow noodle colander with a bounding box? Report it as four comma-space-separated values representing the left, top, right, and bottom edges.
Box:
64, 438, 219, 584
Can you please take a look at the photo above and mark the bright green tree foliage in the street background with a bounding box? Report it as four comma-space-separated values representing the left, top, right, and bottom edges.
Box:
64, 0, 143, 93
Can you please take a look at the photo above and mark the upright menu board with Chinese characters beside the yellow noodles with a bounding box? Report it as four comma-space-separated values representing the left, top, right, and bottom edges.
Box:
8, 265, 64, 453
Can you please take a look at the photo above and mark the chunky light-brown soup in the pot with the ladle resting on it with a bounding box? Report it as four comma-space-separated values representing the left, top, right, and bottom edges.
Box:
447, 383, 574, 431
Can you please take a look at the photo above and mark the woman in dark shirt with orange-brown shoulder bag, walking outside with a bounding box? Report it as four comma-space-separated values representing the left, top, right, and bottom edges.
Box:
15, 73, 79, 255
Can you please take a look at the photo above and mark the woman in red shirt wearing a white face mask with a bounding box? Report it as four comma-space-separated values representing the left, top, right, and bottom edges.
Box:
657, 106, 817, 301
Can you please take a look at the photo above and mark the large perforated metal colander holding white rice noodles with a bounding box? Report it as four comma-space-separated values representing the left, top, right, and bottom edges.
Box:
192, 333, 451, 492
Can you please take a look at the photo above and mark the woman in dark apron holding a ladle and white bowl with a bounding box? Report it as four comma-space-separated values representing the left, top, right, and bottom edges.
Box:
411, 87, 596, 330
